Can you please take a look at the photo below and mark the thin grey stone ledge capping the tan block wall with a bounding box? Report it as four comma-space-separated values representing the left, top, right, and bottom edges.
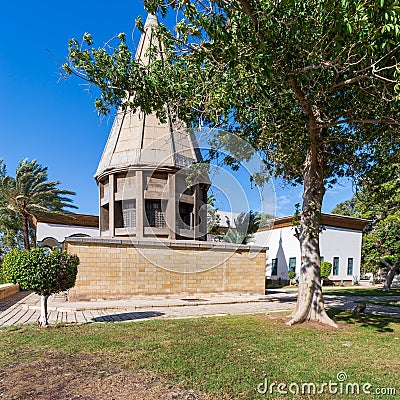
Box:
65, 237, 268, 252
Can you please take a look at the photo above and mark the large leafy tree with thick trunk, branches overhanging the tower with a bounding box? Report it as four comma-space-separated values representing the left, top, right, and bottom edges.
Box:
64, 0, 400, 325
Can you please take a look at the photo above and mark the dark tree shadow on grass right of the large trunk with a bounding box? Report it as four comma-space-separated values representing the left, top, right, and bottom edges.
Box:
327, 308, 399, 333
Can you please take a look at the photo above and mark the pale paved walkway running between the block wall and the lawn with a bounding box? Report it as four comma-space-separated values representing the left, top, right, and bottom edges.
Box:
0, 290, 400, 327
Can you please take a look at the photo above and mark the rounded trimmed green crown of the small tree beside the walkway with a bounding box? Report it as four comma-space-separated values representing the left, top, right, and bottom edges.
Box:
3, 248, 79, 296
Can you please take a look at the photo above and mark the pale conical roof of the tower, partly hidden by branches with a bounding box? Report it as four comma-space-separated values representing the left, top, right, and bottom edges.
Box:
95, 14, 200, 180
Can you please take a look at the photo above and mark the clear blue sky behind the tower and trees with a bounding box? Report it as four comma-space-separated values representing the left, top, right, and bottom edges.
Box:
0, 0, 352, 216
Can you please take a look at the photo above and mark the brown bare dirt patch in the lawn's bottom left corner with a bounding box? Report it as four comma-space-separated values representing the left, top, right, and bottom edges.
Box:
0, 354, 209, 400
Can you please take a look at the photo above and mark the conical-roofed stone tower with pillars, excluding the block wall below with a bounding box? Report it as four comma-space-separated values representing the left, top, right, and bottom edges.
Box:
95, 15, 210, 240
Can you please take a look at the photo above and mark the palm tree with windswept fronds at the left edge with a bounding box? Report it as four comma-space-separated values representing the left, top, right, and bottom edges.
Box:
0, 159, 76, 250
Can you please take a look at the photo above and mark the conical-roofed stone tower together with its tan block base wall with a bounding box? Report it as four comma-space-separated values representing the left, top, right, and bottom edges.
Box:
65, 15, 266, 301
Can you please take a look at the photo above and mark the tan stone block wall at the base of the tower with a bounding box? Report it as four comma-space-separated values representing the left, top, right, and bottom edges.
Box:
65, 238, 266, 301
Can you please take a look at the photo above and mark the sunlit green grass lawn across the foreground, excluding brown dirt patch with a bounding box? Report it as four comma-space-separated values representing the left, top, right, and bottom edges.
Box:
0, 310, 400, 399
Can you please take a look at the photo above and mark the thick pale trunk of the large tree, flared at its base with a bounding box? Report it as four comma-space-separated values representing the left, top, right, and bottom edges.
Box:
287, 146, 337, 328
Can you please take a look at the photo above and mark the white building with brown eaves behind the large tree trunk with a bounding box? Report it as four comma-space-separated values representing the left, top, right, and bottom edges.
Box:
254, 214, 370, 284
